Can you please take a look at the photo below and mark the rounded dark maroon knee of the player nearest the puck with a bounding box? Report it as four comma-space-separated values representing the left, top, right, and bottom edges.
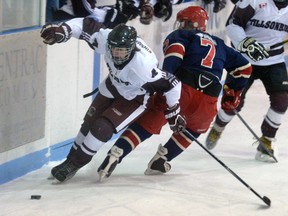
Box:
90, 117, 115, 142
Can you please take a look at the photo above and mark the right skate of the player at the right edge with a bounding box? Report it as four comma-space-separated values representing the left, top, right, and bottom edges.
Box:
255, 136, 275, 162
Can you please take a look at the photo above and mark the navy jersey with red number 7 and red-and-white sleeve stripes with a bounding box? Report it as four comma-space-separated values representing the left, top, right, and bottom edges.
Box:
163, 29, 251, 90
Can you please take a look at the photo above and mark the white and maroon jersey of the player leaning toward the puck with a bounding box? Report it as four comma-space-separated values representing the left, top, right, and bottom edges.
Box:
66, 18, 181, 107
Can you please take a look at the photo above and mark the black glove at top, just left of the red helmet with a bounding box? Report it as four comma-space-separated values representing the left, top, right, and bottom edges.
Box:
154, 0, 173, 22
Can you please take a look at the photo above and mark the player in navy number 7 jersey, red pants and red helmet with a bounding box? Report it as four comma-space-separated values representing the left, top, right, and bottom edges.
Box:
98, 6, 251, 180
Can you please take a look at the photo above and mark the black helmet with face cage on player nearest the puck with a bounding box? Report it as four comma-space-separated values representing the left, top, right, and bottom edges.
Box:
108, 24, 137, 65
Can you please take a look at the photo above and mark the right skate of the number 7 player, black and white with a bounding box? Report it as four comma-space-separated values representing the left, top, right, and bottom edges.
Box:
144, 144, 171, 175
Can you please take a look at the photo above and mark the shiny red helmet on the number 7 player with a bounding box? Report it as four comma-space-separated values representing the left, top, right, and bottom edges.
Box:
175, 6, 209, 31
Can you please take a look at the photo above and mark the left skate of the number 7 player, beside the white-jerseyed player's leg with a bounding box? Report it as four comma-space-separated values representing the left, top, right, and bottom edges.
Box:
98, 146, 123, 181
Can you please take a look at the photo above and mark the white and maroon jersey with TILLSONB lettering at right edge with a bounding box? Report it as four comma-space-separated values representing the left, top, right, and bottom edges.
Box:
226, 0, 288, 65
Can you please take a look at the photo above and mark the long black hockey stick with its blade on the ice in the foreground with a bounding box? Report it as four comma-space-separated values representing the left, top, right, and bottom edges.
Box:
184, 130, 271, 207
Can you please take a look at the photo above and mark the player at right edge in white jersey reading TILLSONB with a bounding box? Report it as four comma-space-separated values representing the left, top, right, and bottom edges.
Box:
206, 0, 288, 162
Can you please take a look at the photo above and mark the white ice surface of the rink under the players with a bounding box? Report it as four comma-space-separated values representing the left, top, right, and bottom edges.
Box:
0, 82, 288, 216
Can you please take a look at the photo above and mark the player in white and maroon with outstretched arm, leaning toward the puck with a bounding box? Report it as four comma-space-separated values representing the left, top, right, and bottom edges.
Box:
41, 17, 182, 182
